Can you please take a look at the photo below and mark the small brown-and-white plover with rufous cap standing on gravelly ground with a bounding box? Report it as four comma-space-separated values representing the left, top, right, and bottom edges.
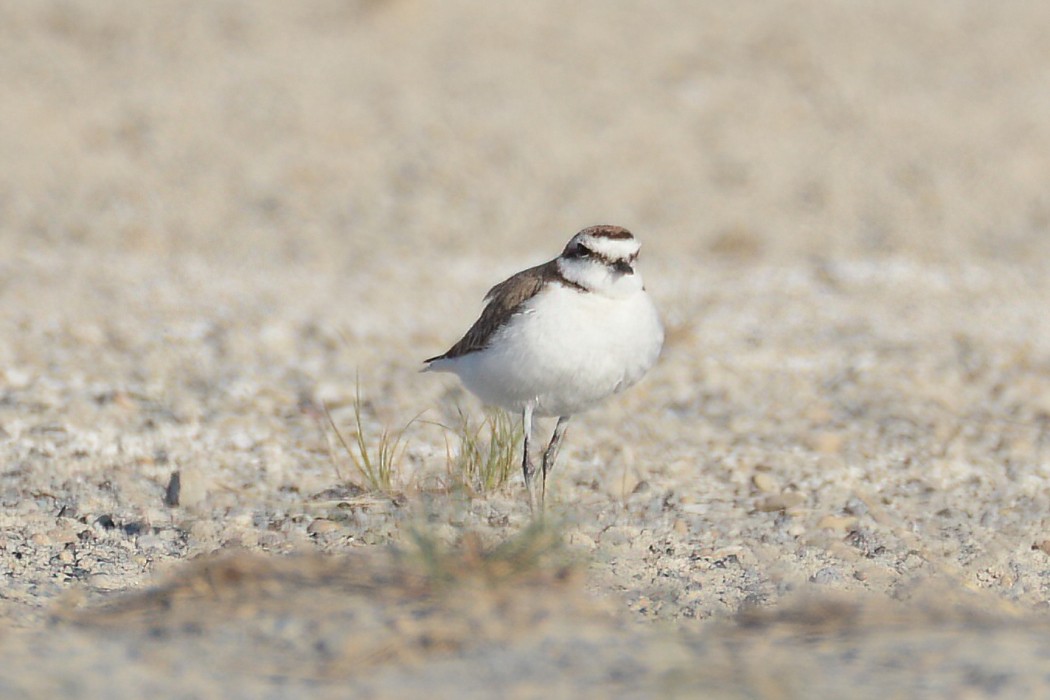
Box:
424, 226, 664, 502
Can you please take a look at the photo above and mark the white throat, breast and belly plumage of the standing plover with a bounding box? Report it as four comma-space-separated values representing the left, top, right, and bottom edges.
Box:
431, 260, 664, 416
